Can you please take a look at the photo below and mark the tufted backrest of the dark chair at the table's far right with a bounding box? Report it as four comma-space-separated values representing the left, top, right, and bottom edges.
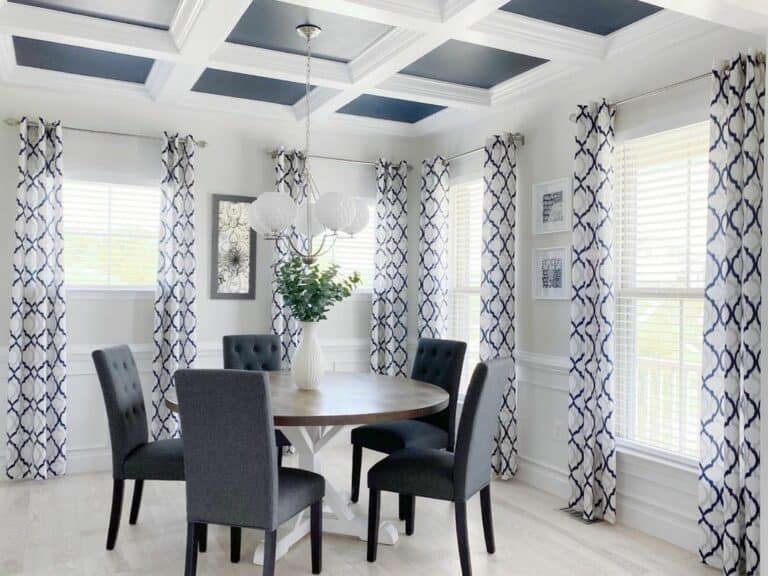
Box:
411, 338, 467, 450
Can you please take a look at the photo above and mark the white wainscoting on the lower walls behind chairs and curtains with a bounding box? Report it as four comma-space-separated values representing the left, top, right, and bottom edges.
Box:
0, 339, 698, 551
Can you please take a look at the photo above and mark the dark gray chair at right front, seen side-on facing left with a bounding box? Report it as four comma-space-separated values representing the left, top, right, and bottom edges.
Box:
368, 358, 512, 576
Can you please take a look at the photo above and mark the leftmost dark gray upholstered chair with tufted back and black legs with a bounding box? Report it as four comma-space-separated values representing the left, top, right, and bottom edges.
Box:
92, 346, 186, 550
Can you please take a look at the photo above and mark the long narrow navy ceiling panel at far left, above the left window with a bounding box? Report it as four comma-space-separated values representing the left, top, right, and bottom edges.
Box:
13, 36, 154, 84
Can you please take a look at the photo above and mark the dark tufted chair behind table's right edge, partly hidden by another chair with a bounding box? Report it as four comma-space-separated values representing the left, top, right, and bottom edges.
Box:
351, 338, 467, 520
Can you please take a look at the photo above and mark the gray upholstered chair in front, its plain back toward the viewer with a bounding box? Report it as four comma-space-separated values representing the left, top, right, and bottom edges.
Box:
175, 370, 325, 576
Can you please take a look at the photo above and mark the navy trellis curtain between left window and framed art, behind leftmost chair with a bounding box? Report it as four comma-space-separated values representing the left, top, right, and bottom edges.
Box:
152, 133, 197, 440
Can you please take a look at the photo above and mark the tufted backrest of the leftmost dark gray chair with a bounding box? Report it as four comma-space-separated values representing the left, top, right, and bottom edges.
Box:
91, 346, 149, 479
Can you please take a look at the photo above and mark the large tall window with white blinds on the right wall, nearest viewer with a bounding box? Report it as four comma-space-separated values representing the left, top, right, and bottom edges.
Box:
616, 123, 709, 458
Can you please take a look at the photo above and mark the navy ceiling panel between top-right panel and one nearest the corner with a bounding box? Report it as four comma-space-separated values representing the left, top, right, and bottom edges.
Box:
400, 40, 546, 88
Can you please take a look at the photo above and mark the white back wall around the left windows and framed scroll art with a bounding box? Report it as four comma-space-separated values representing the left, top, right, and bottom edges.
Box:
0, 86, 420, 471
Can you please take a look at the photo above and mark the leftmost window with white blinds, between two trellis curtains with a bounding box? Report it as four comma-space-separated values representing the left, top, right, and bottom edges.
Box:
62, 180, 160, 289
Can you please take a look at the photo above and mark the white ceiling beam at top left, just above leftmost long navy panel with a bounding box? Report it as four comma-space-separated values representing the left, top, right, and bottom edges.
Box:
0, 2, 179, 60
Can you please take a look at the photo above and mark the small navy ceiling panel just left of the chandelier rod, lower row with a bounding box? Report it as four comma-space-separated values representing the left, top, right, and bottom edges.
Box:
192, 68, 312, 105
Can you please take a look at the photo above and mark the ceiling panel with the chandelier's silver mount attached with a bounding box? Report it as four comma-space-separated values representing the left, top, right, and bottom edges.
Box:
227, 0, 392, 62
